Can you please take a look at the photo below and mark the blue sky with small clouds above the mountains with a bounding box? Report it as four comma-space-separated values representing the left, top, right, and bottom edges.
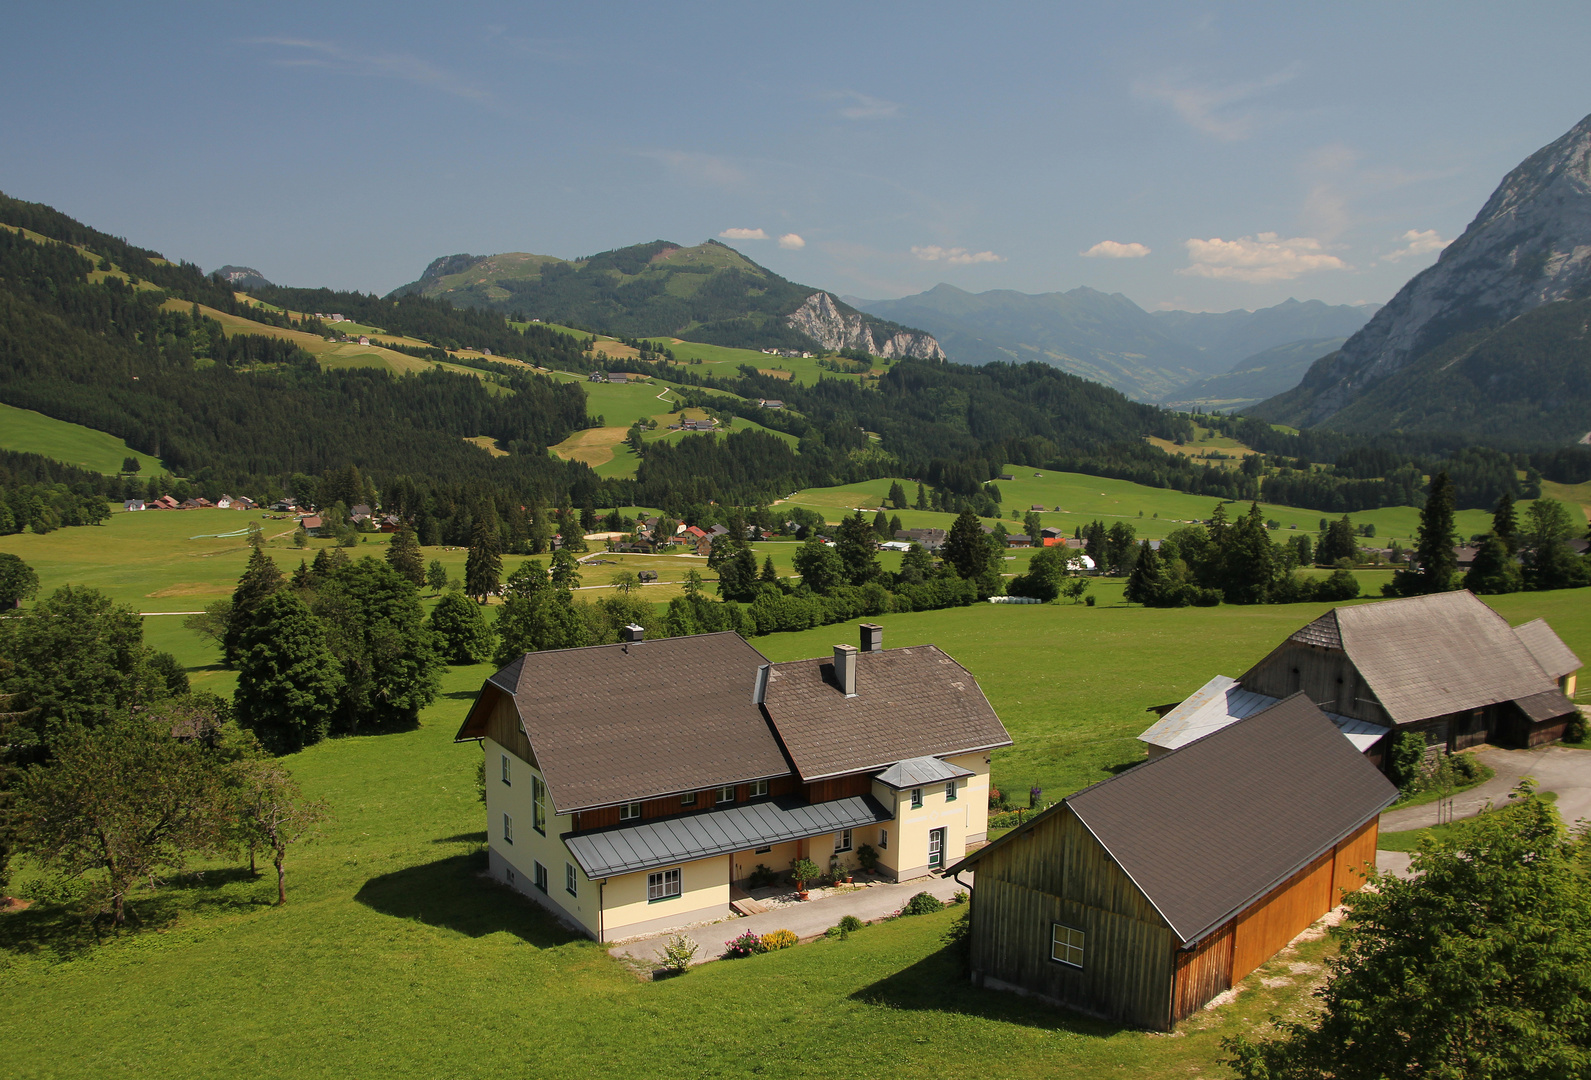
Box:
0, 3, 1591, 310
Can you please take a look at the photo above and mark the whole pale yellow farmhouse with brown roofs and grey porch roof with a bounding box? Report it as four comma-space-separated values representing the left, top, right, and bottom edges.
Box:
457, 624, 1010, 942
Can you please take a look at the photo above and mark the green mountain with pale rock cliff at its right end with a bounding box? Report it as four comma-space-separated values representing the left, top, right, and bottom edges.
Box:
391, 240, 943, 359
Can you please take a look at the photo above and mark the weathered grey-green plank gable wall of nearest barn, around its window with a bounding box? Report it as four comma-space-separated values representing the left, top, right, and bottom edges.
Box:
972, 806, 1176, 1029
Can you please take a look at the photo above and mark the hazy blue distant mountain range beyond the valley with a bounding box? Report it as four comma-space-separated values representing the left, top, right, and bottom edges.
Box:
846, 285, 1376, 407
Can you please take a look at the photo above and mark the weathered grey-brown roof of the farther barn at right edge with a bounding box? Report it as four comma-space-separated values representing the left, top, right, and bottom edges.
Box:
1266, 592, 1573, 724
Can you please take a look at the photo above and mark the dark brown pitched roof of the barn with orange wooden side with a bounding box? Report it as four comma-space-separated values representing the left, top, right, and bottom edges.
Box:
950, 693, 1397, 945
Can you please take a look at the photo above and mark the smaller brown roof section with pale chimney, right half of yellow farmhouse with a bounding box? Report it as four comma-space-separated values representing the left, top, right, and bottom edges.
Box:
764, 646, 1010, 781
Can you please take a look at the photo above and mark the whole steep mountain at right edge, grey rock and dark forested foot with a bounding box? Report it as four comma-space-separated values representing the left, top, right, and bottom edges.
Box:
1252, 116, 1591, 442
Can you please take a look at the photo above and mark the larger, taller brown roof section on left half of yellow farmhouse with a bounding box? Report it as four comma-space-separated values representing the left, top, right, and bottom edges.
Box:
470, 631, 791, 814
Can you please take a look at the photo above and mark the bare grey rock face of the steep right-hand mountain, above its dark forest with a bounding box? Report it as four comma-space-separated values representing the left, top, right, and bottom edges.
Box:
1260, 116, 1591, 425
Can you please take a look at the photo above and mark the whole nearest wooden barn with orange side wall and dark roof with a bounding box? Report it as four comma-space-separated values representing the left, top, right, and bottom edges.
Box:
950, 693, 1397, 1031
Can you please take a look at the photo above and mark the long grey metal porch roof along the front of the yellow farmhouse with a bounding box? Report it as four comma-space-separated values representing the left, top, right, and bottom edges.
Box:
563, 795, 891, 878
